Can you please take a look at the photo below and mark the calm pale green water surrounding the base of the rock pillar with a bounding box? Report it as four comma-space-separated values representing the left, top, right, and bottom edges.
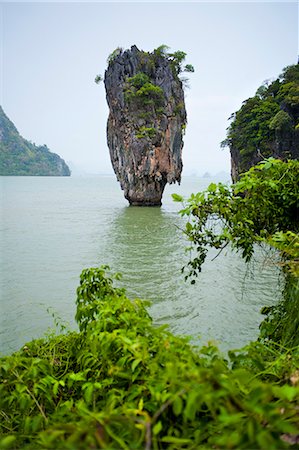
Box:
0, 176, 279, 353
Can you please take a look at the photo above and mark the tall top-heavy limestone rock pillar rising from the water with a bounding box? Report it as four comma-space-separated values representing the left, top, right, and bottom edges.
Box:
104, 46, 186, 206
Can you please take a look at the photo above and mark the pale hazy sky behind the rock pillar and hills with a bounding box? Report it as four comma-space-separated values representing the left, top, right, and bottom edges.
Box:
0, 1, 298, 174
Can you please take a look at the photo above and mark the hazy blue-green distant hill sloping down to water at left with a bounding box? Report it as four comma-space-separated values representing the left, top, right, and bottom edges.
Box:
0, 106, 71, 176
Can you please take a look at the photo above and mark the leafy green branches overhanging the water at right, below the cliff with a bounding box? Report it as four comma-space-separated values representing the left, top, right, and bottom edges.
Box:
173, 158, 299, 277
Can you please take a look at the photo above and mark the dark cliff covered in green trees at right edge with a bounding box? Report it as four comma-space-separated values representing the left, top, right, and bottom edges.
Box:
222, 64, 299, 182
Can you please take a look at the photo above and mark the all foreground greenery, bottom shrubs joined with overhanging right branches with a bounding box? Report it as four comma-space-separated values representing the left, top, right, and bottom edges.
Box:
0, 159, 299, 450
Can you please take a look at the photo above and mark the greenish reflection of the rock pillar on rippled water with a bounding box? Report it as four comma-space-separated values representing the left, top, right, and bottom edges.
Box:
107, 207, 184, 302
